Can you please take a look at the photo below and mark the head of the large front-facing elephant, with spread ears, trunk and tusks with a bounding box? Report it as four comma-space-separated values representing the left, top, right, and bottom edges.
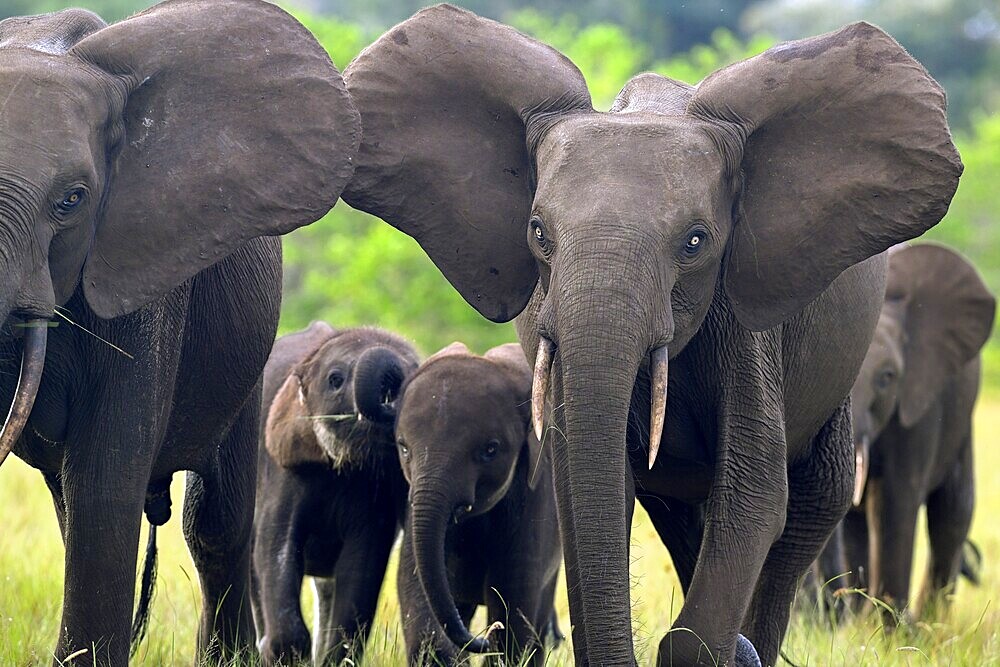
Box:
344, 5, 962, 664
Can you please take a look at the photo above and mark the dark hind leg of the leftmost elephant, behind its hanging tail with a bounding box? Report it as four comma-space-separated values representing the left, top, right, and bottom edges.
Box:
184, 394, 260, 659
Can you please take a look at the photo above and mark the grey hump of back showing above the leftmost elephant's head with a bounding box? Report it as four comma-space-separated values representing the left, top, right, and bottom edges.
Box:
0, 9, 108, 55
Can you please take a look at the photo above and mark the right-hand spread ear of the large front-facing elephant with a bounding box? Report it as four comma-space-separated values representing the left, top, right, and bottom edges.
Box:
689, 23, 962, 330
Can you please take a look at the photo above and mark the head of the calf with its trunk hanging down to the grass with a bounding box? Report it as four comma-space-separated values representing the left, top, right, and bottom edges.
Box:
396, 343, 541, 652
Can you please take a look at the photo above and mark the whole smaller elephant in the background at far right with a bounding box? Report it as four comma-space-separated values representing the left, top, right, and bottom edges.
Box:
823, 243, 996, 611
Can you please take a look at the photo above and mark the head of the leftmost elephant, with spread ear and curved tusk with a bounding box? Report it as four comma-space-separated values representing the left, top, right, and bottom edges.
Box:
0, 0, 360, 470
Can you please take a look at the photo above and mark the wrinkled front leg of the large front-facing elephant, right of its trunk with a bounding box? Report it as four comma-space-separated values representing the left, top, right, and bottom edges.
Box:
657, 366, 788, 667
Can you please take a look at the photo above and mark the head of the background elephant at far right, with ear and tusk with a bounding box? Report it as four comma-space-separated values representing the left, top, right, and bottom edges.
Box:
851, 243, 996, 505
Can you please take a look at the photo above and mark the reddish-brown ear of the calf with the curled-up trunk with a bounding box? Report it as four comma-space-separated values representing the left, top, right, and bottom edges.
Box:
264, 373, 327, 468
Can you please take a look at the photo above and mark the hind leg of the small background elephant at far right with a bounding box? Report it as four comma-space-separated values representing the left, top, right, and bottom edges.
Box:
919, 442, 975, 614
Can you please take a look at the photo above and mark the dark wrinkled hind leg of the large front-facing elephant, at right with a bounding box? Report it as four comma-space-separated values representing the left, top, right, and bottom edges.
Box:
743, 401, 854, 665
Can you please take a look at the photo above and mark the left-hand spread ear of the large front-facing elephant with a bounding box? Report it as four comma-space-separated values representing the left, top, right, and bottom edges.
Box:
344, 5, 592, 322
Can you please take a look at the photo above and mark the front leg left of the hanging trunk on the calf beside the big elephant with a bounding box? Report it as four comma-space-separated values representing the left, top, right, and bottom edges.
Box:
396, 532, 462, 667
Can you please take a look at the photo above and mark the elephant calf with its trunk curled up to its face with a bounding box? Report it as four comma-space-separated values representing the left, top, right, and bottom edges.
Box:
253, 322, 418, 665
